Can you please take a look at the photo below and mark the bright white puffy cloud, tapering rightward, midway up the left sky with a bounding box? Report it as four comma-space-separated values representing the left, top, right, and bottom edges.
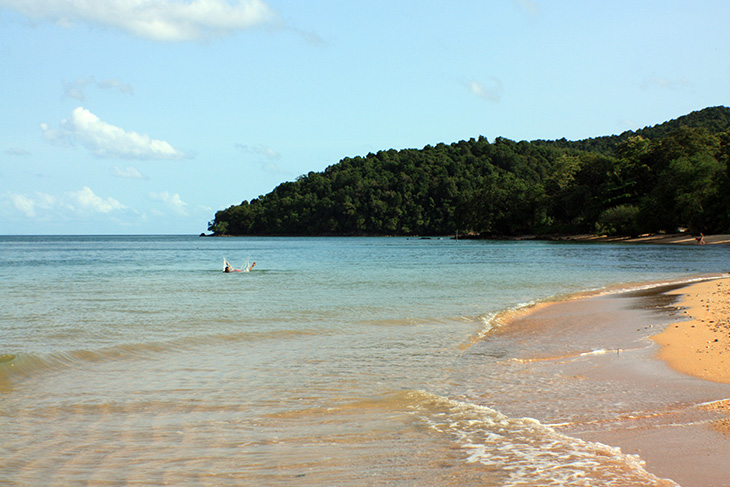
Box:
41, 107, 185, 159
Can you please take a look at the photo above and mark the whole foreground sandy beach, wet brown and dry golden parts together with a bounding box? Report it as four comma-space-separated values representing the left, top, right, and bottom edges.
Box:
502, 279, 730, 487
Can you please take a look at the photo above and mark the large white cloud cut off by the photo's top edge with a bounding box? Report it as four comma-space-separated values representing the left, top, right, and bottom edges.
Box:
0, 0, 275, 41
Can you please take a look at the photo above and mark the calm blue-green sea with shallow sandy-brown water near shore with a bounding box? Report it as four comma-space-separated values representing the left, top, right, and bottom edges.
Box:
0, 236, 730, 486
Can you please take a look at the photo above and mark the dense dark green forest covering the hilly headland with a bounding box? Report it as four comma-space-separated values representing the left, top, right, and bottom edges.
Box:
208, 107, 730, 236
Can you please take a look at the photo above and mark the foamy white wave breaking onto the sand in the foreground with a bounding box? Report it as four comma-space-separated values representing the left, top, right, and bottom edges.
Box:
403, 391, 677, 486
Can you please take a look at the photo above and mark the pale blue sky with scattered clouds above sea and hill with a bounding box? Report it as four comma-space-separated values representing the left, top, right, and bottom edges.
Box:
0, 0, 730, 235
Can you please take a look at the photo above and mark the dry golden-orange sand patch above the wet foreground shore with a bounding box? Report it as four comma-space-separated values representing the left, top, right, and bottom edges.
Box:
653, 279, 730, 384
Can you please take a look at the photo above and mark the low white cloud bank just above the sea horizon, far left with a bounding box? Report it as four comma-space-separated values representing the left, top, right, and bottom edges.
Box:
6, 186, 127, 218
